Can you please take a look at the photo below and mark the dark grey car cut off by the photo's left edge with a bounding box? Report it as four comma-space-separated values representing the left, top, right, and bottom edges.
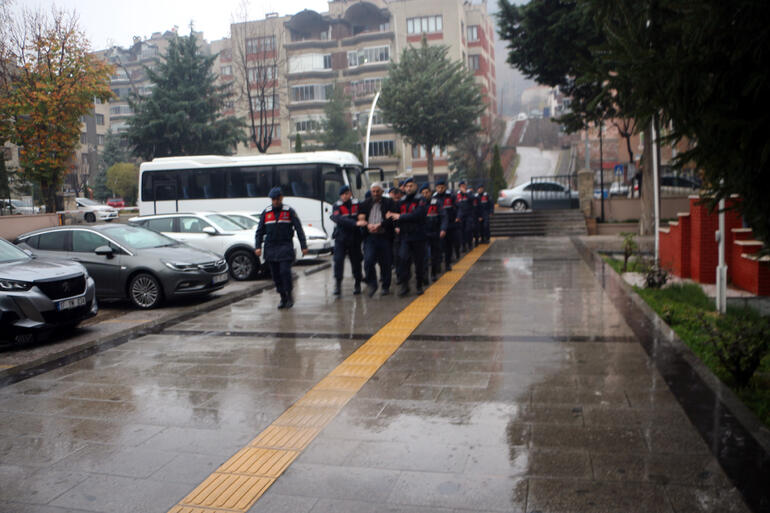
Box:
0, 239, 98, 340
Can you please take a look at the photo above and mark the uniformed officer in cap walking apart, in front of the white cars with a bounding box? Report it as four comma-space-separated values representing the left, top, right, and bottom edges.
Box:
254, 187, 307, 309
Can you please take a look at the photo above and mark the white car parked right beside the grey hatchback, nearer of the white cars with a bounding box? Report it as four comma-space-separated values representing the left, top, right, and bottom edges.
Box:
128, 212, 302, 281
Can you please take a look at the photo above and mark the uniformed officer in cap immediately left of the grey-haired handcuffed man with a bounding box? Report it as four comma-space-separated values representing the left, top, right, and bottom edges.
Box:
332, 185, 366, 296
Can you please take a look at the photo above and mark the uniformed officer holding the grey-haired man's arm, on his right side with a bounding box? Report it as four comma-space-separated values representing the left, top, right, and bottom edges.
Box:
386, 178, 427, 296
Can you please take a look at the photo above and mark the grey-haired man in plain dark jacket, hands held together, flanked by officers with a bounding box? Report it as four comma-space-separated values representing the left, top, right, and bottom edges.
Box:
358, 183, 398, 297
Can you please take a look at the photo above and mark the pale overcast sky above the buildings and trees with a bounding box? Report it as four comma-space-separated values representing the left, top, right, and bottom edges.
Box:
12, 0, 328, 50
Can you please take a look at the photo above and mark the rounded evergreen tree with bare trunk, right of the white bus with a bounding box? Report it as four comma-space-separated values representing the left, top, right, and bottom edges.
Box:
379, 38, 485, 185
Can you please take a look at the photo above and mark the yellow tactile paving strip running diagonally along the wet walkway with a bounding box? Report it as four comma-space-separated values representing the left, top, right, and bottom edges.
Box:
169, 241, 489, 513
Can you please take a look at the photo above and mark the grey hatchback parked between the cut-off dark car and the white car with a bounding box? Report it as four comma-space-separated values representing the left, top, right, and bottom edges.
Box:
16, 224, 228, 308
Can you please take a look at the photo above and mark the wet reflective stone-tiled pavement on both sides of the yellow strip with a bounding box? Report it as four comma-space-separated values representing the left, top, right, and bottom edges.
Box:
0, 238, 760, 513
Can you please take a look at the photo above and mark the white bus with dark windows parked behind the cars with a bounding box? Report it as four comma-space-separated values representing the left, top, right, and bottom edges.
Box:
138, 151, 382, 235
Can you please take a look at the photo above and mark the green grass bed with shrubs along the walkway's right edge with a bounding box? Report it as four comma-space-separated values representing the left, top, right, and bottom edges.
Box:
632, 282, 770, 426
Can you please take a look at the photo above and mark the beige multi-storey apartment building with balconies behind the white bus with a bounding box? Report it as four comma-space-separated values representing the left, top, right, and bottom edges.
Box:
219, 0, 497, 181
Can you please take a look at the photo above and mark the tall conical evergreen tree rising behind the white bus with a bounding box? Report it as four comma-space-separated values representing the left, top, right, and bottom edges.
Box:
128, 30, 245, 160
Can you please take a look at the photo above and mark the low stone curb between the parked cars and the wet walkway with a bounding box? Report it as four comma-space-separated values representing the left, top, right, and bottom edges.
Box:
0, 262, 331, 388
